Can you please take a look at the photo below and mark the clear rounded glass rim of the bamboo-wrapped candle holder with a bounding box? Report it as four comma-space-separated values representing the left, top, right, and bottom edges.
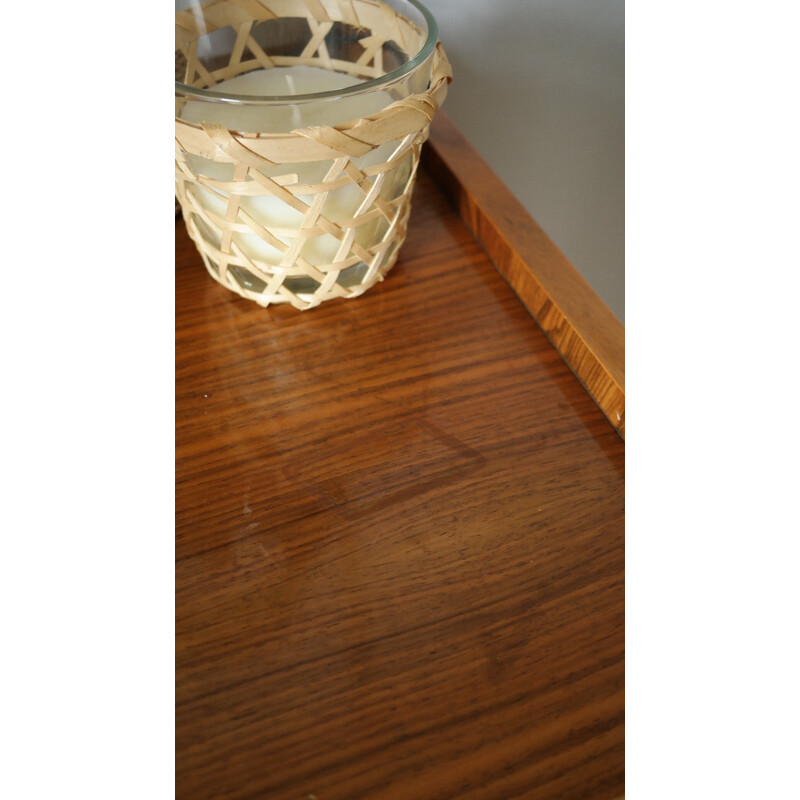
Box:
175, 0, 439, 105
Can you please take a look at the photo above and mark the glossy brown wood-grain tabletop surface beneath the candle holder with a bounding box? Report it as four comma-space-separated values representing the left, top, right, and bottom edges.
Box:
176, 161, 624, 800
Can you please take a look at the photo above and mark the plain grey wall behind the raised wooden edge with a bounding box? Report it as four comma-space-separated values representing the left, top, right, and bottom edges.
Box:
422, 0, 625, 322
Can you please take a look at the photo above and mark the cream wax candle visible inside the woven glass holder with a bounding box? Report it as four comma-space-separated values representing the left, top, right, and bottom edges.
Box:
181, 66, 410, 291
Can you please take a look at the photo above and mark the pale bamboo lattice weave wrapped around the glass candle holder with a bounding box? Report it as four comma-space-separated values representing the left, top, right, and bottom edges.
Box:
175, 0, 452, 309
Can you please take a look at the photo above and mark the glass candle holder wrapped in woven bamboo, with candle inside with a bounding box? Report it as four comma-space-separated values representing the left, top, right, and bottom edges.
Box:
175, 0, 452, 309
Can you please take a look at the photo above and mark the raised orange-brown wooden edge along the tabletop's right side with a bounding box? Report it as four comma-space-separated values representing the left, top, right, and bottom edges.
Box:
422, 111, 625, 439
